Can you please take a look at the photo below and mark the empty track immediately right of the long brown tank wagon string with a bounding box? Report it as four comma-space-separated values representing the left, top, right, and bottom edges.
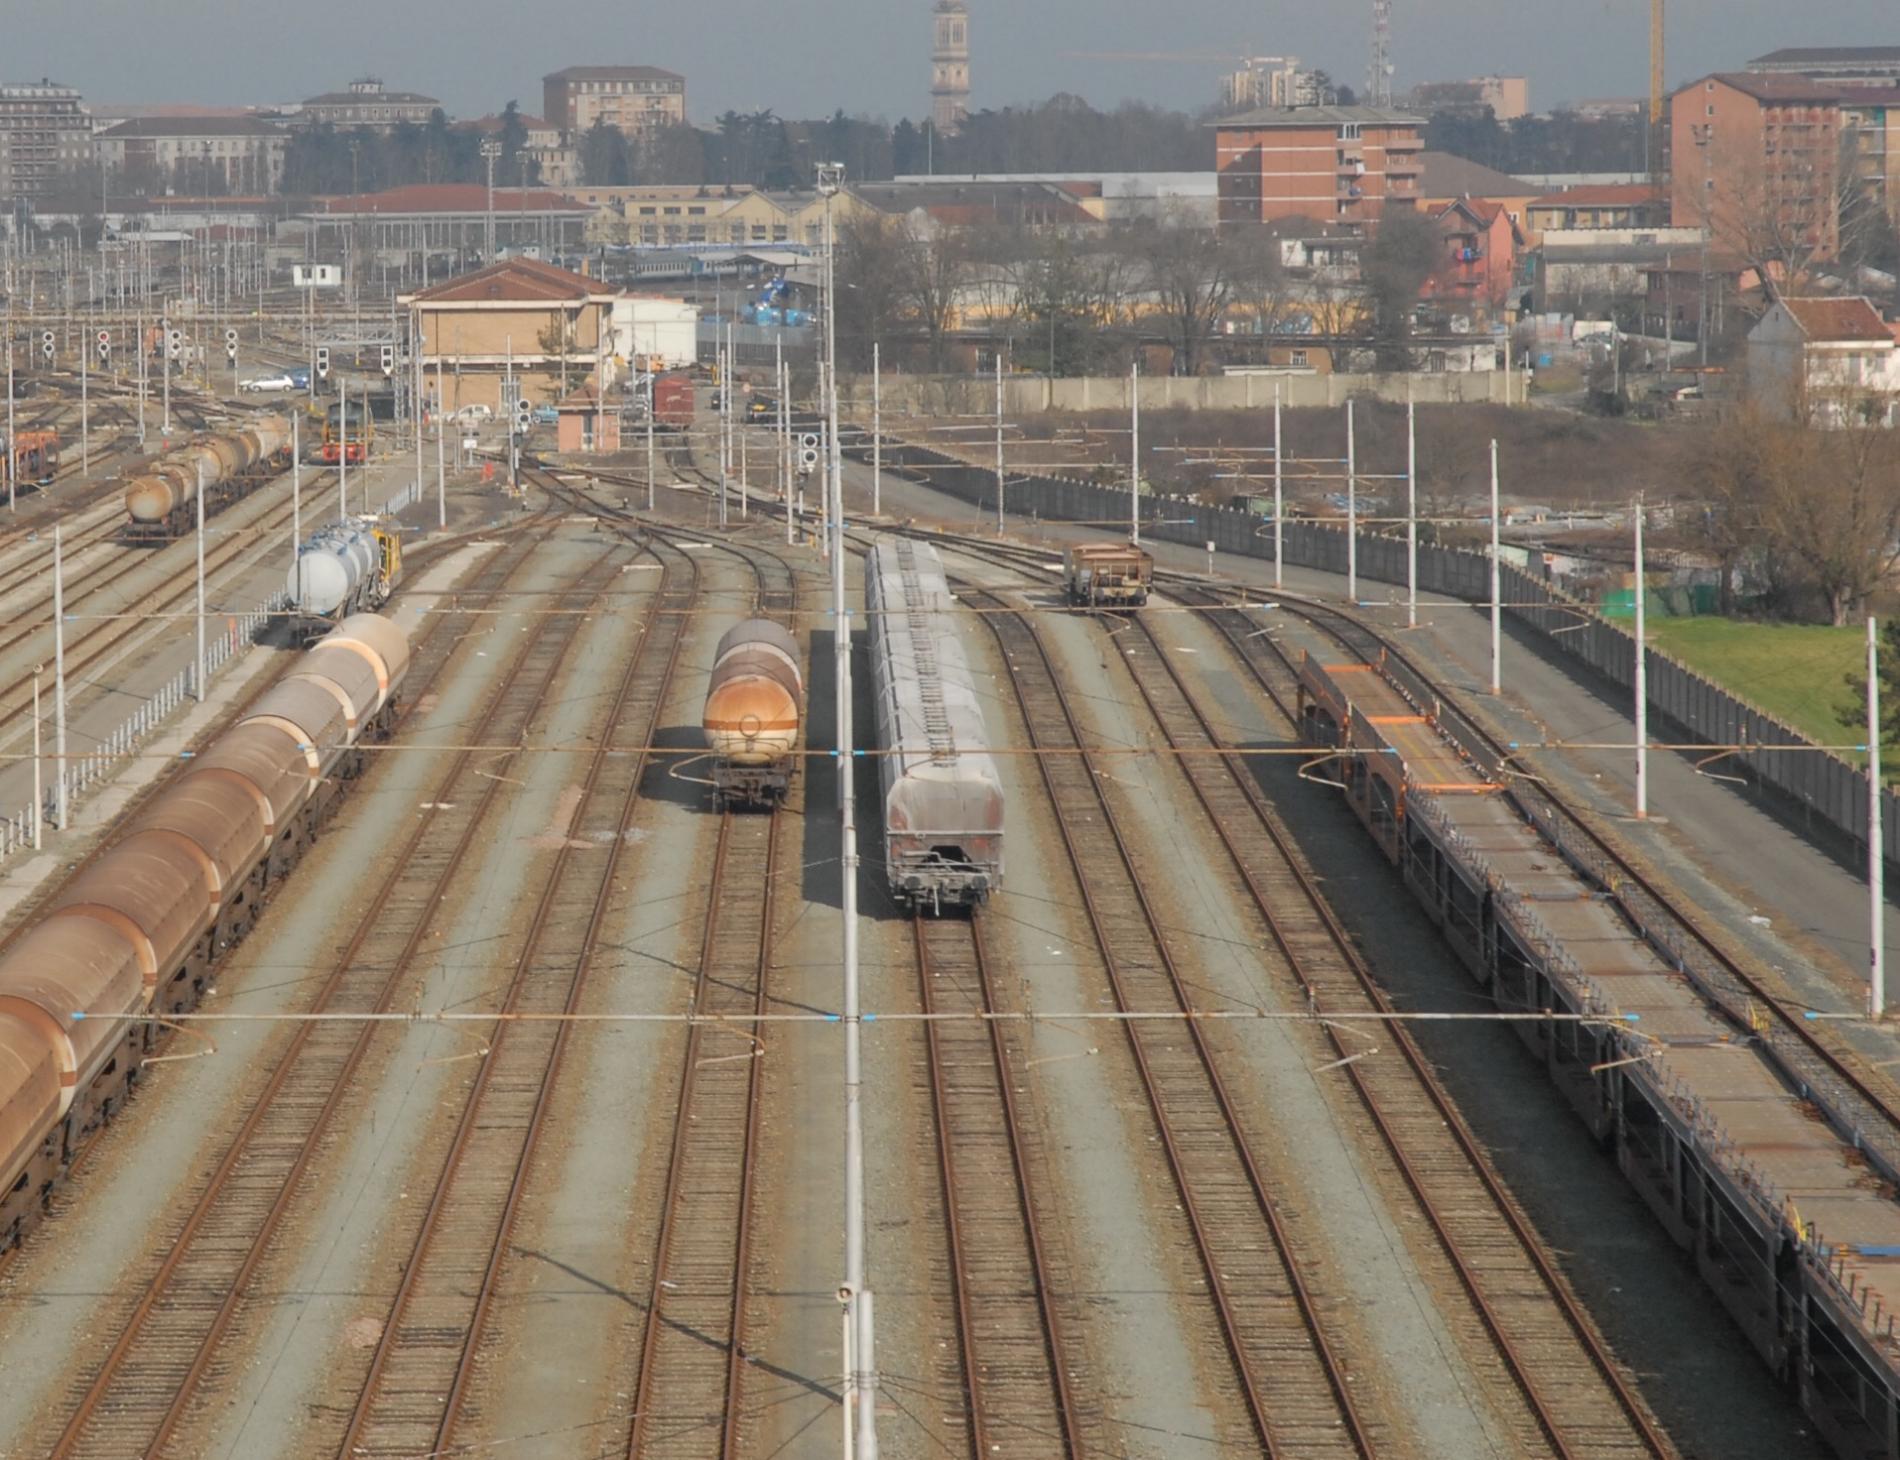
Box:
48, 517, 618, 1456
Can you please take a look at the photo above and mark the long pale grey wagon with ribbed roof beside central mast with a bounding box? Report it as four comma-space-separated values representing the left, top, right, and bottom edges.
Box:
865, 538, 1003, 913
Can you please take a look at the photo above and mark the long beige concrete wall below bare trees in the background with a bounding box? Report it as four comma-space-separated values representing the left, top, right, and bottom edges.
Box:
840, 371, 1524, 416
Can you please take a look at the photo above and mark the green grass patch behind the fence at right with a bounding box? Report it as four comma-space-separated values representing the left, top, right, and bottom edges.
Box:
1645, 618, 1854, 759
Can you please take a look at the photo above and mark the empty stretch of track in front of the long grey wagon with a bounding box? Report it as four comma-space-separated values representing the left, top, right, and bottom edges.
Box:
912, 913, 1098, 1460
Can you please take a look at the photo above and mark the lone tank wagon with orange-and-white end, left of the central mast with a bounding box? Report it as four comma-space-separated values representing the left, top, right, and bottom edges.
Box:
701, 618, 806, 806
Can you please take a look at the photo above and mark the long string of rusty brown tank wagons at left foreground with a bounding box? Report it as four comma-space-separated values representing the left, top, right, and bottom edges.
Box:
0, 614, 409, 1251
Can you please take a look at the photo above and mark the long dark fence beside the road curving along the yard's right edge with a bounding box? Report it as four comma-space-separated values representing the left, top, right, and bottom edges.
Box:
853, 439, 1900, 869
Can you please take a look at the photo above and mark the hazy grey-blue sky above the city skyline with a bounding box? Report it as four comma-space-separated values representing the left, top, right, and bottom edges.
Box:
18, 0, 1900, 122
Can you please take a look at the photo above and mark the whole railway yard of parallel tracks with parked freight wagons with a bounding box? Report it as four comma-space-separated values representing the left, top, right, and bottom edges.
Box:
0, 323, 1900, 1460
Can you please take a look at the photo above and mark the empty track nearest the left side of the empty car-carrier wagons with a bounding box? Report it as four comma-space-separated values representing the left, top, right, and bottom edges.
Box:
1115, 616, 1674, 1460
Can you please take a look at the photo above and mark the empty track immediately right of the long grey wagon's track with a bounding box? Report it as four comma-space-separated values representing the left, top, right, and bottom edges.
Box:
960, 586, 1379, 1460
